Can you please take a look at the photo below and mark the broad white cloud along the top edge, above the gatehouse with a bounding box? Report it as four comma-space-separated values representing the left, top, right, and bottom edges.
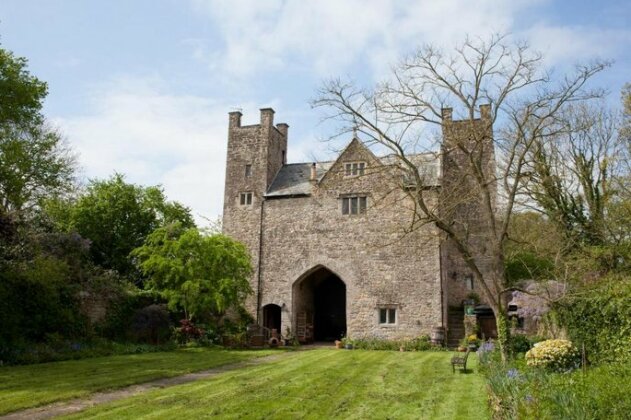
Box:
192, 0, 536, 77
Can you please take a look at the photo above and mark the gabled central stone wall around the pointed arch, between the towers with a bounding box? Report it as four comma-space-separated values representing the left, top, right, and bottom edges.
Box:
261, 140, 442, 338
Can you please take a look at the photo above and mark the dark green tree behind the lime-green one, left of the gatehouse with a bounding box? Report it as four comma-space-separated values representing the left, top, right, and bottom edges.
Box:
53, 174, 195, 281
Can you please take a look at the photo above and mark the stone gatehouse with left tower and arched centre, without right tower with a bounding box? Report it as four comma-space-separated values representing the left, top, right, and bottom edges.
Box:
223, 108, 488, 341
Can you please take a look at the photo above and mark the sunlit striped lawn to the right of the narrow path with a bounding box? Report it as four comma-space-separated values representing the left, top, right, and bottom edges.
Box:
65, 349, 489, 419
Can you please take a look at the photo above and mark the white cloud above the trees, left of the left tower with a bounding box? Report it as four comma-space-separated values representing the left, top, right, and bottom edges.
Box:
55, 79, 242, 224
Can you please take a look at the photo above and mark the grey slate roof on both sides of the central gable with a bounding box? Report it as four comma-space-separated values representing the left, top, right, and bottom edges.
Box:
265, 153, 440, 198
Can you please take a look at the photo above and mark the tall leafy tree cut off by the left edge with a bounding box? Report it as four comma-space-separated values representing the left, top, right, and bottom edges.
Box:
0, 48, 75, 216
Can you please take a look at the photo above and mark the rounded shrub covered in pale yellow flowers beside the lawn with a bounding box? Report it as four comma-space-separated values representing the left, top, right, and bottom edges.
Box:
526, 339, 580, 371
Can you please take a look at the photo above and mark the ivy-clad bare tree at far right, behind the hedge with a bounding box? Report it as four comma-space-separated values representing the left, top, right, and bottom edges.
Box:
526, 103, 627, 249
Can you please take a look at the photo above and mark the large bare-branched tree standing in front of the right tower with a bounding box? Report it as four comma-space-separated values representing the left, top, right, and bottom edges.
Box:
313, 35, 608, 358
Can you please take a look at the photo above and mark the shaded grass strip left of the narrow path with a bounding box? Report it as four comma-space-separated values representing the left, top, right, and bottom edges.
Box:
0, 348, 272, 415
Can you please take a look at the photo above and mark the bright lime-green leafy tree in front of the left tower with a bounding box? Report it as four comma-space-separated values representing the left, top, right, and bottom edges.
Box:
133, 223, 252, 321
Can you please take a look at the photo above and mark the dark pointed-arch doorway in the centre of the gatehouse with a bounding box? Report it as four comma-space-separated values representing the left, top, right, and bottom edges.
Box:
293, 266, 346, 342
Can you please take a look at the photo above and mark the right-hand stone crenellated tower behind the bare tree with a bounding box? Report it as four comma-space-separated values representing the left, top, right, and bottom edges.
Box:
440, 105, 497, 346
